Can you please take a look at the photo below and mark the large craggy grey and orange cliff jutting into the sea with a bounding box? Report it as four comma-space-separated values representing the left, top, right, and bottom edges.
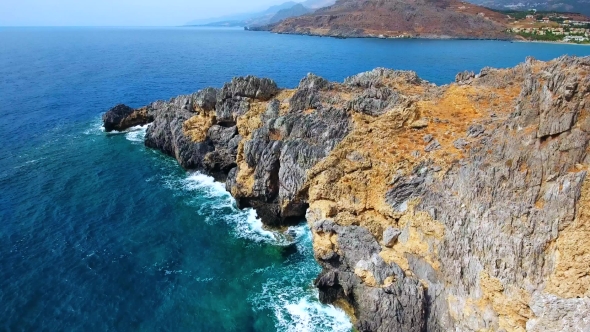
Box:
105, 57, 590, 331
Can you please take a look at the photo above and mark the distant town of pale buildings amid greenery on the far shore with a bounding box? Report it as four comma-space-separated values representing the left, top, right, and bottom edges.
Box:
507, 10, 590, 44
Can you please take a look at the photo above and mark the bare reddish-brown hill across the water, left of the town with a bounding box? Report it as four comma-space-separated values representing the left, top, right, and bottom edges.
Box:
261, 0, 508, 39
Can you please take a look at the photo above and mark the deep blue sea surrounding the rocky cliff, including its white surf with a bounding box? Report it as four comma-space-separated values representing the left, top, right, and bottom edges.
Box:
0, 28, 590, 331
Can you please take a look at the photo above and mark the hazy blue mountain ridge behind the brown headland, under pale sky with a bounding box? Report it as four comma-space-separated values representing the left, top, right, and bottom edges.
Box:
186, 0, 336, 27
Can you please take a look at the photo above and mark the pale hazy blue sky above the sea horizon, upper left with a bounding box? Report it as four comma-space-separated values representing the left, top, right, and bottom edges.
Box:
0, 0, 287, 26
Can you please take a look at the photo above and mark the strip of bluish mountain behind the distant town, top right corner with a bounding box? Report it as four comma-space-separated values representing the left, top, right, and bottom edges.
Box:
468, 0, 590, 16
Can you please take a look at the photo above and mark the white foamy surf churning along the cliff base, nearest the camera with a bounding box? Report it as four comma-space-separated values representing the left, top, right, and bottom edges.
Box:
164, 172, 352, 332
